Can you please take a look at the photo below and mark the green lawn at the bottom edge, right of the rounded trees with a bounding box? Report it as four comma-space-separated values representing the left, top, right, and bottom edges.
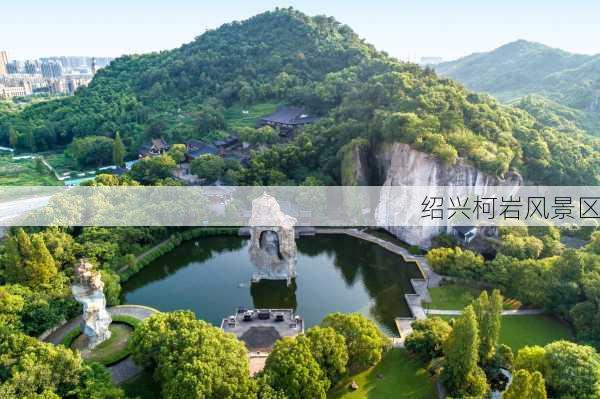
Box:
328, 349, 437, 399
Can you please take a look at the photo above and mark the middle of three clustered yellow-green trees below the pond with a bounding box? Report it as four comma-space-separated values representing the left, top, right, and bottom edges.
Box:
297, 326, 348, 385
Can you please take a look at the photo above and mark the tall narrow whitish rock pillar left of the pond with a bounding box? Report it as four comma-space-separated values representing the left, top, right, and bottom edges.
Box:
71, 259, 112, 349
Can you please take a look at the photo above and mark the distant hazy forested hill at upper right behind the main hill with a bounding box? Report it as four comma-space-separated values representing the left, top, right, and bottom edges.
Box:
436, 40, 600, 135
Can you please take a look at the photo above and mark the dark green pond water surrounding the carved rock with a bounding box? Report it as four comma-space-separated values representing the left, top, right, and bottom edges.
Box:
123, 235, 421, 335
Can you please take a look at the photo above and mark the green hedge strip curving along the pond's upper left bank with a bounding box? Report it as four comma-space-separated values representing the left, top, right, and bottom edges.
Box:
119, 227, 238, 282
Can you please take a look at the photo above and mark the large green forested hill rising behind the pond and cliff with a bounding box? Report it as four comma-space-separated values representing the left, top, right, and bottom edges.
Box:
0, 9, 600, 184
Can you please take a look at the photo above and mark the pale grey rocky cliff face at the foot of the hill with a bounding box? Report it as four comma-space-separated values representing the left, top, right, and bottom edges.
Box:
370, 143, 523, 248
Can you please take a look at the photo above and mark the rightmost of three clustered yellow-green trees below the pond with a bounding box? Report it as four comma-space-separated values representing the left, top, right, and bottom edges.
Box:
321, 313, 389, 370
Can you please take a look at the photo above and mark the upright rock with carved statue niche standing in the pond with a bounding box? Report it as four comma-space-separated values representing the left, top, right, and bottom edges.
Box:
249, 193, 296, 284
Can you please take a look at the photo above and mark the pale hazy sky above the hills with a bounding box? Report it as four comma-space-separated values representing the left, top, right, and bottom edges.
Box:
0, 0, 600, 61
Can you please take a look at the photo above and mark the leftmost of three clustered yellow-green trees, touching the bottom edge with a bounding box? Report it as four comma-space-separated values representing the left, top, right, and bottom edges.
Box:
263, 337, 330, 399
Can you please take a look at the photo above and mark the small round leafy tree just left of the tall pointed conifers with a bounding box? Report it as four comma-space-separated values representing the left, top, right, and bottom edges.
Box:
404, 317, 452, 361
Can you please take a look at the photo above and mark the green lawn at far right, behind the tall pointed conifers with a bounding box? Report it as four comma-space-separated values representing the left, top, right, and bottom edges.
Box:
500, 315, 573, 352
